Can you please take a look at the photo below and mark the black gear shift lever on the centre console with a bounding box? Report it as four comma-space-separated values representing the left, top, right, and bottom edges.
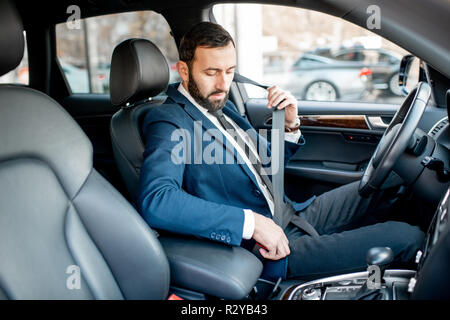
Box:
354, 247, 394, 300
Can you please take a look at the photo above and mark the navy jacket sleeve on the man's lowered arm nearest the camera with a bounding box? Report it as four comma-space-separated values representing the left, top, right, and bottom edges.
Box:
137, 120, 244, 246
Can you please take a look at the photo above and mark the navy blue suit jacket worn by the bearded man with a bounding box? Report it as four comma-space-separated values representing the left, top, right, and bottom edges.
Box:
137, 84, 313, 278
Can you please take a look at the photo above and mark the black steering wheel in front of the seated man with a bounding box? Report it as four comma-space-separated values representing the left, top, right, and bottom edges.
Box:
358, 82, 431, 197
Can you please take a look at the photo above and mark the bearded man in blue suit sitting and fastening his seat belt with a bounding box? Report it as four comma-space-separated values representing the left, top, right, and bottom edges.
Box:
138, 22, 423, 278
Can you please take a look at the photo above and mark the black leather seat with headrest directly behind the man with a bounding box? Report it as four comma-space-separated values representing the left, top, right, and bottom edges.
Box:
110, 39, 169, 201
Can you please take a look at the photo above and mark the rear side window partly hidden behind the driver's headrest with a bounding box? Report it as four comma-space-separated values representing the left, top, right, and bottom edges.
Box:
56, 11, 178, 94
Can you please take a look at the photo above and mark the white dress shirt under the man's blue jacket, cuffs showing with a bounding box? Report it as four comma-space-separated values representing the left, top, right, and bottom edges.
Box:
178, 83, 301, 239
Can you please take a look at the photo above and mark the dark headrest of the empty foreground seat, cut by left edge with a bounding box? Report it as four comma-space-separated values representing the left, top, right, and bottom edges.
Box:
0, 0, 24, 76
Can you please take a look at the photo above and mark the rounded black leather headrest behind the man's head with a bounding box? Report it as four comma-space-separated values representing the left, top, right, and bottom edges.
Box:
109, 39, 169, 106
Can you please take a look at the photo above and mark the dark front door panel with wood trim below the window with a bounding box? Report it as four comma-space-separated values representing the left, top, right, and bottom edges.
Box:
245, 99, 445, 201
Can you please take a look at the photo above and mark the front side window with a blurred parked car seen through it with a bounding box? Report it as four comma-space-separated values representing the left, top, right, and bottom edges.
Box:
213, 4, 407, 104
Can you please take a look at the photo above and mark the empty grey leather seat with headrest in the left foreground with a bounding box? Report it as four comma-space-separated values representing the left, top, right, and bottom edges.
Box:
0, 0, 170, 299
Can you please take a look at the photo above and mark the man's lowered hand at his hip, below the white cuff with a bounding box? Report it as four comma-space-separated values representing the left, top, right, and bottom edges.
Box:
253, 212, 291, 260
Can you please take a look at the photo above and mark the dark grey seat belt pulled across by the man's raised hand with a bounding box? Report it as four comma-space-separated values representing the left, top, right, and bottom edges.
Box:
233, 72, 319, 237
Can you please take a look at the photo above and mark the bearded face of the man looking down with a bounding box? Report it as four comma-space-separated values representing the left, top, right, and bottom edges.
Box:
188, 41, 236, 111
